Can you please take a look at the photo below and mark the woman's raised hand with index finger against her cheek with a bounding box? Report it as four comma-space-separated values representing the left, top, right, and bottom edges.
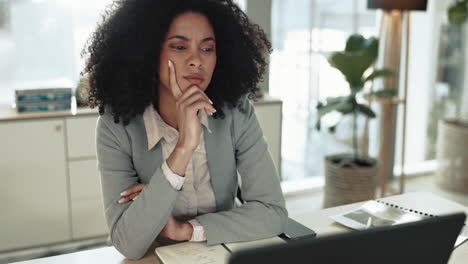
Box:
168, 60, 216, 151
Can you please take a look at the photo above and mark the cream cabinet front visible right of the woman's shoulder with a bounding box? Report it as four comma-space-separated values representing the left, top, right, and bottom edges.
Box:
255, 102, 282, 178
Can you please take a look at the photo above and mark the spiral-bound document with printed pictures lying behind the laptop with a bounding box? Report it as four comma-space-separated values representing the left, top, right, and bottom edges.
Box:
330, 200, 468, 248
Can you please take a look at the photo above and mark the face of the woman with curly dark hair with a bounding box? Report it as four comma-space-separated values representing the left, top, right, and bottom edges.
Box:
159, 12, 216, 95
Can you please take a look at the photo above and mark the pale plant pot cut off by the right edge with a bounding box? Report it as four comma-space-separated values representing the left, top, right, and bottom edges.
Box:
435, 119, 468, 193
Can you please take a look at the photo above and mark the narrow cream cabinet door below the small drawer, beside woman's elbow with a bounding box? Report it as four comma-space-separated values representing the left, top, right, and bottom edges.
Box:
69, 160, 109, 239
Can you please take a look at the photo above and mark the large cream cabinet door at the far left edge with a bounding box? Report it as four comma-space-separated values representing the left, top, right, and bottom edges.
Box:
0, 119, 71, 251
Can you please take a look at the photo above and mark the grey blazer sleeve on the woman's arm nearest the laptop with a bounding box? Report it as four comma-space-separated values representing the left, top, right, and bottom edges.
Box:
196, 99, 288, 245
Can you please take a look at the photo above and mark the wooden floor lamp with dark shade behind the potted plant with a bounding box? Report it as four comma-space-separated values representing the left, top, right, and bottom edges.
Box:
367, 0, 427, 197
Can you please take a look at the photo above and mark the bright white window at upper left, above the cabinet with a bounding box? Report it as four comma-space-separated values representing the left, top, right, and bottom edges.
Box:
0, 0, 115, 104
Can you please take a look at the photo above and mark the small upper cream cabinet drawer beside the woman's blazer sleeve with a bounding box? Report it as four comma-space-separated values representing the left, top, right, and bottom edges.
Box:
65, 116, 98, 159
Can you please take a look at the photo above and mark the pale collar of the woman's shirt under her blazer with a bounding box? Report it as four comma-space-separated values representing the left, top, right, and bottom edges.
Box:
143, 104, 211, 150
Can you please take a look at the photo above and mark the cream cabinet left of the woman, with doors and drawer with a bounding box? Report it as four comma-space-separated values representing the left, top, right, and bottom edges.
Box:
0, 114, 108, 251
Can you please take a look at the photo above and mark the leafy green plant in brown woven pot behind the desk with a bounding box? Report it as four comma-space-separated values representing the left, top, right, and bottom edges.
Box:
316, 34, 396, 207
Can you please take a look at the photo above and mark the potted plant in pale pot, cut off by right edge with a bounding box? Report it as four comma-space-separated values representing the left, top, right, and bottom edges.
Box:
435, 0, 468, 193
